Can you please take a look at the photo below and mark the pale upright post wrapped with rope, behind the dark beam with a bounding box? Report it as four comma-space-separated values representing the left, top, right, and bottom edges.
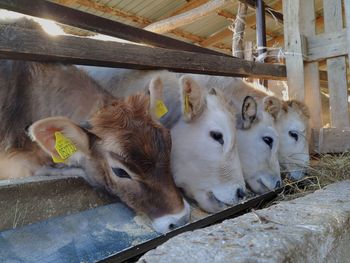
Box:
232, 3, 248, 58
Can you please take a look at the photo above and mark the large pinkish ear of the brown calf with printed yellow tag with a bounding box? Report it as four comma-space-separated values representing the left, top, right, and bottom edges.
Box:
28, 117, 90, 163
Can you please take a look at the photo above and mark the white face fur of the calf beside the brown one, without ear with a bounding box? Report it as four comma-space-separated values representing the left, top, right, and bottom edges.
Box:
171, 95, 245, 212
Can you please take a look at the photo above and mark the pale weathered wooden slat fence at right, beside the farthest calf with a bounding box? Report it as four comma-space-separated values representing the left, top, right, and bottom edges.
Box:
283, 0, 350, 152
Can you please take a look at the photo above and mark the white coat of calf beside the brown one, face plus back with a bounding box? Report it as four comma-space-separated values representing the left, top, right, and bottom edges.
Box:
83, 67, 245, 212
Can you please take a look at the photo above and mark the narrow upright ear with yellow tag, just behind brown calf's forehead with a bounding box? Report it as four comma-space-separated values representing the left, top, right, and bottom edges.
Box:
148, 77, 168, 121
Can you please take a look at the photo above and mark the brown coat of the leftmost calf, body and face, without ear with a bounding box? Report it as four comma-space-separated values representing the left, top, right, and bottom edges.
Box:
0, 60, 184, 218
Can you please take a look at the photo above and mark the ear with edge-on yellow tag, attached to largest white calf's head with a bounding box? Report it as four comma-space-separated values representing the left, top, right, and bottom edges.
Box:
180, 76, 205, 122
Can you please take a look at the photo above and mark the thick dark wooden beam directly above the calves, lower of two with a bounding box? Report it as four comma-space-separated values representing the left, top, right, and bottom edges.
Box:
0, 26, 286, 79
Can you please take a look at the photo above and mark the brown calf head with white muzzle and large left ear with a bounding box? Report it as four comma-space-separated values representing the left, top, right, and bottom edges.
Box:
29, 94, 189, 232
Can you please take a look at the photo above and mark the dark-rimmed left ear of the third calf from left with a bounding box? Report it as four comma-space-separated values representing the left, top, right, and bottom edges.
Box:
237, 96, 258, 129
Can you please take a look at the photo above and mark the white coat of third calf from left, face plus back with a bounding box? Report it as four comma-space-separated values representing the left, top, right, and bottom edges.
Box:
187, 75, 281, 193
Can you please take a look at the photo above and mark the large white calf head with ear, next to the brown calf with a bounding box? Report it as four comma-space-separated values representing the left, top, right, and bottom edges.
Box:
167, 75, 245, 212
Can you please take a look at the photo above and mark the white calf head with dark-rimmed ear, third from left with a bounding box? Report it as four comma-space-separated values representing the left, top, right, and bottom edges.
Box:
237, 96, 281, 194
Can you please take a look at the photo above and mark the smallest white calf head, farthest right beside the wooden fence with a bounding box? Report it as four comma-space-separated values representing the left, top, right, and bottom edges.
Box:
276, 100, 310, 180
